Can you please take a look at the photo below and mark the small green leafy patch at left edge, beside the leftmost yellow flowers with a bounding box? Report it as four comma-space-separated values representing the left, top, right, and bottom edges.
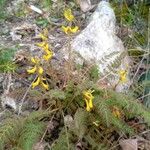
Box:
0, 47, 16, 72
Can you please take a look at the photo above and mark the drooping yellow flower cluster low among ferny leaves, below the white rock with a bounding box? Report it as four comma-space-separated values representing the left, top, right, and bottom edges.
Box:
83, 90, 94, 111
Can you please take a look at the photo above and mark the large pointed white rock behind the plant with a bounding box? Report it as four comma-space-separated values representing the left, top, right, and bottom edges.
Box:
72, 1, 128, 91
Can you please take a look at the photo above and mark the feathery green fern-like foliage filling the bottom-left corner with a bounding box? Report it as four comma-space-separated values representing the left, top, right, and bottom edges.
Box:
0, 111, 50, 150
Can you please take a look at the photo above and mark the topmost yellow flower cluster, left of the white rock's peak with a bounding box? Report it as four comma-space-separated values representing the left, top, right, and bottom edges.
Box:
62, 9, 79, 34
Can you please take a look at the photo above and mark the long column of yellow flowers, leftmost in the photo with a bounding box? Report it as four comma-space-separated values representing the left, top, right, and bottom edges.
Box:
27, 29, 53, 90
